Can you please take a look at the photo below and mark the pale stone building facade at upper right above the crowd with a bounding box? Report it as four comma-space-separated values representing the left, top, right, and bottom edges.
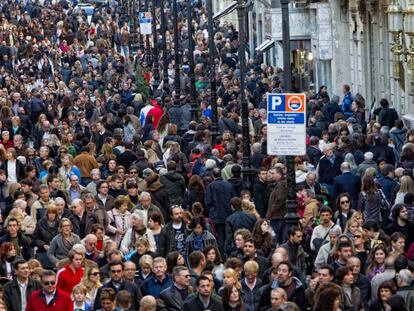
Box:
254, 0, 414, 117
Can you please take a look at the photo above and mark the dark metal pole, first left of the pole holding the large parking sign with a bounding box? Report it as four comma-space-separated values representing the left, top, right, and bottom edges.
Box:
237, 0, 252, 189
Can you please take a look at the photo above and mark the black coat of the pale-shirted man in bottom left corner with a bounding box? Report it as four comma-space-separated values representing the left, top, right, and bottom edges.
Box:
3, 278, 41, 311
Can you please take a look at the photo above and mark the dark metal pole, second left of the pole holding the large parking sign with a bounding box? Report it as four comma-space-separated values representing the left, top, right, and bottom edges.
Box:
207, 0, 220, 146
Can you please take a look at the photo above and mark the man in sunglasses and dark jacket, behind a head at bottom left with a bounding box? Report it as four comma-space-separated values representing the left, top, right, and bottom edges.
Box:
93, 260, 142, 311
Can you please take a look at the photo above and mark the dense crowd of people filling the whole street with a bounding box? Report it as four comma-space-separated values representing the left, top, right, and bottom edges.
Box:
0, 0, 414, 311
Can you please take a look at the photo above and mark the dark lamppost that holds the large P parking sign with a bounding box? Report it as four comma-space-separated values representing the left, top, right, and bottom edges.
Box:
281, 0, 299, 226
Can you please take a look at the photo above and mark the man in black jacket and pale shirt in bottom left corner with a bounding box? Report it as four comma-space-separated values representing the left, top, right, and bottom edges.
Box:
3, 259, 41, 311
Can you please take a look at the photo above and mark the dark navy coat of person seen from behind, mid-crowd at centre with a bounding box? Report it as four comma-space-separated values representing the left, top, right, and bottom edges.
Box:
204, 178, 236, 224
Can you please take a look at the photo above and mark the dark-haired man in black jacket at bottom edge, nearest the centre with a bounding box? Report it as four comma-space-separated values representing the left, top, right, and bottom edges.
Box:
181, 275, 224, 311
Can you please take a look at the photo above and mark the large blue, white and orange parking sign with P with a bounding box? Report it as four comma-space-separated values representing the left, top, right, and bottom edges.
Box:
267, 94, 306, 156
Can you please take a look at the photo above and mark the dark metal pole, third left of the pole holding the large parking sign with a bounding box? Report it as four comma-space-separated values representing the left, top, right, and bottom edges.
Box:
187, 0, 198, 121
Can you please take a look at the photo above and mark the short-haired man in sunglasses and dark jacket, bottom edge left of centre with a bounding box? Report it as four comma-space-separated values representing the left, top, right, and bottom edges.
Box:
160, 266, 193, 311
